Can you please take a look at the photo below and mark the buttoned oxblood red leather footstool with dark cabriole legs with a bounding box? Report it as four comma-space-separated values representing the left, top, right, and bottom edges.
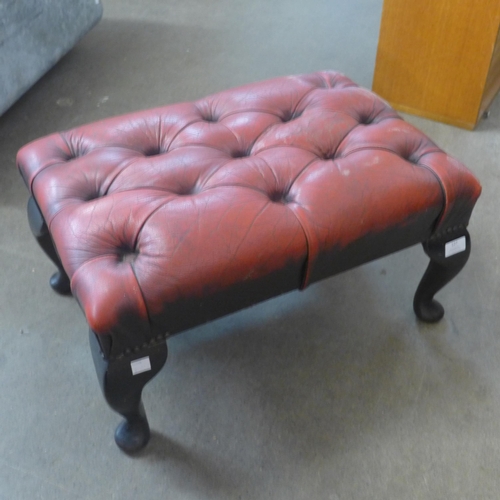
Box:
18, 72, 481, 452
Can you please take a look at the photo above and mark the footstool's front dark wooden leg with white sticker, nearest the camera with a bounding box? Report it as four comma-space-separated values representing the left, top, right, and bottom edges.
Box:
90, 330, 168, 453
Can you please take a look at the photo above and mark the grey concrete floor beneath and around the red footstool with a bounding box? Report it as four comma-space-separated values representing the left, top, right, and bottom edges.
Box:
0, 0, 500, 500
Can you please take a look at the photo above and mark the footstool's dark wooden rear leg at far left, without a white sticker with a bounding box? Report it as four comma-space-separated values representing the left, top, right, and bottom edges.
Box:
28, 197, 71, 295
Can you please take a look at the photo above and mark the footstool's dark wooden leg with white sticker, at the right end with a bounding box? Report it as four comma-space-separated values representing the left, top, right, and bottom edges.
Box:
413, 229, 470, 323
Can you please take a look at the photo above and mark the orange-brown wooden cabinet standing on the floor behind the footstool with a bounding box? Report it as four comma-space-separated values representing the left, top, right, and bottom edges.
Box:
373, 0, 500, 129
